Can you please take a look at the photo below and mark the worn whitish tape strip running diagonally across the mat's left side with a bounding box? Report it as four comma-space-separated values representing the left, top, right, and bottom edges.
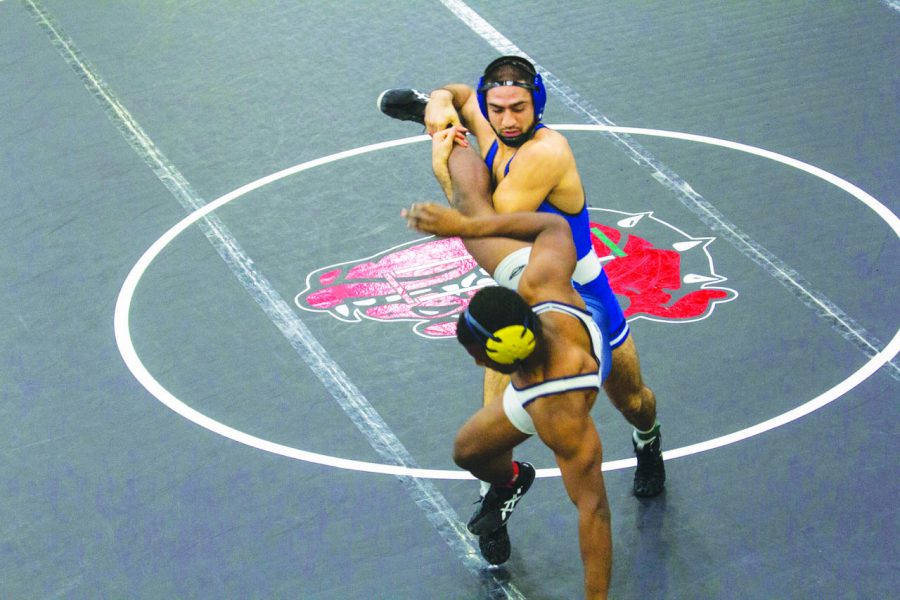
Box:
24, 0, 524, 600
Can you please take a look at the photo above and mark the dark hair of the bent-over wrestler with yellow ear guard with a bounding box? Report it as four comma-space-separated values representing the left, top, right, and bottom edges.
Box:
456, 285, 540, 346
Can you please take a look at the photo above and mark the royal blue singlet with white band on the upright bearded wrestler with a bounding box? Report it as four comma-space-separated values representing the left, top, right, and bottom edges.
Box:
484, 123, 630, 376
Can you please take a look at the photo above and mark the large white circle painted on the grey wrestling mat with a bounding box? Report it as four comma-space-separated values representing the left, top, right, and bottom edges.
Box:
113, 125, 900, 479
